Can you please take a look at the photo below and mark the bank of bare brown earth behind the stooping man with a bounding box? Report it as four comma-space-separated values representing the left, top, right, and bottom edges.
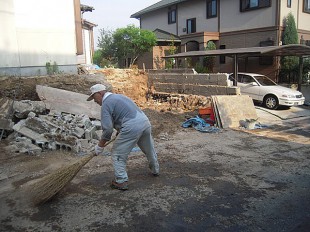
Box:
0, 68, 197, 142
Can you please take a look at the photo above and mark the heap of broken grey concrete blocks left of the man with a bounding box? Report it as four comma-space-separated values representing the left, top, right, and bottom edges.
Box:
1, 103, 101, 154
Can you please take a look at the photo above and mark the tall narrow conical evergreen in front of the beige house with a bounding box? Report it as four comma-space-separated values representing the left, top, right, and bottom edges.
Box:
280, 13, 298, 81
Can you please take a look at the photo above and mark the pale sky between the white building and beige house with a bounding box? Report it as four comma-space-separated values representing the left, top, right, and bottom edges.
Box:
80, 0, 160, 46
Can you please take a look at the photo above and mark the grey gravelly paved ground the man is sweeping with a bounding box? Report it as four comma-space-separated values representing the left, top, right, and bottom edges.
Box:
0, 108, 310, 232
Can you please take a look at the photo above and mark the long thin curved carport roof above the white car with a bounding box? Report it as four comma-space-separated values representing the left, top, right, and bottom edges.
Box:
163, 44, 310, 58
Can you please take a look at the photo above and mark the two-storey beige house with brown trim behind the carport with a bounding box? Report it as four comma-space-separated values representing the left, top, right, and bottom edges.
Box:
131, 0, 310, 79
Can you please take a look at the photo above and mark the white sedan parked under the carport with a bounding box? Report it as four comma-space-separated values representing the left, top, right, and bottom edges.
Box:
229, 73, 305, 109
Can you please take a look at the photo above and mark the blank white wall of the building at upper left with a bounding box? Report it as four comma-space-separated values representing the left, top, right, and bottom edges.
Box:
0, 0, 77, 75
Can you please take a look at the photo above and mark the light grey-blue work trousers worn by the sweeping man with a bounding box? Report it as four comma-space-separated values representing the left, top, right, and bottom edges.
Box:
111, 113, 159, 183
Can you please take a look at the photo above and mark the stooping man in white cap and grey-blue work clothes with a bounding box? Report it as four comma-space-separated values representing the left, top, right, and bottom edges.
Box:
87, 84, 159, 190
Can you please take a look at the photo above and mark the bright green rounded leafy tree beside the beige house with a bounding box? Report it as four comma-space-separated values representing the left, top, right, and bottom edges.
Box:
113, 25, 157, 66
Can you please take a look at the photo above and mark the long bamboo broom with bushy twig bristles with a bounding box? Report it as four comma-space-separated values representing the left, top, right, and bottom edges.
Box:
30, 137, 116, 205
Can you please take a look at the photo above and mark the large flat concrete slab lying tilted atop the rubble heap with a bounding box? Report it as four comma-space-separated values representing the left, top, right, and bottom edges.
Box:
36, 85, 100, 119
